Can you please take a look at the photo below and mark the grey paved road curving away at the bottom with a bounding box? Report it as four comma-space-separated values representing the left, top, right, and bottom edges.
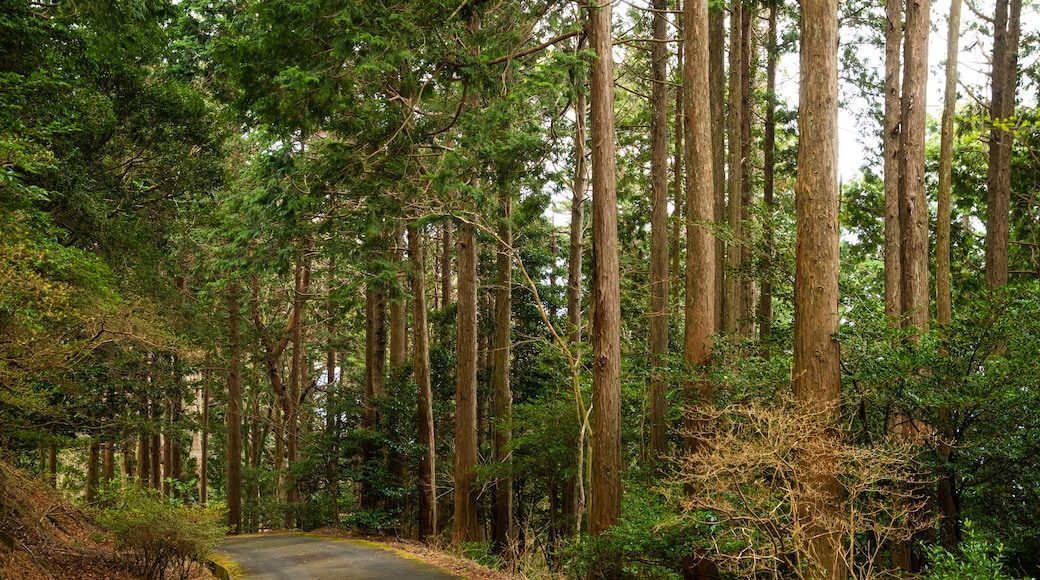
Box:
214, 533, 459, 580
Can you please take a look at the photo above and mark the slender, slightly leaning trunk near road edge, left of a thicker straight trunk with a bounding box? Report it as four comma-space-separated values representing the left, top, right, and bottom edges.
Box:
408, 226, 437, 541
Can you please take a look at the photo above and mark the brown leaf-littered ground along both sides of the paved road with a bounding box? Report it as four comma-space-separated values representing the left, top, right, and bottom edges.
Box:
0, 462, 516, 580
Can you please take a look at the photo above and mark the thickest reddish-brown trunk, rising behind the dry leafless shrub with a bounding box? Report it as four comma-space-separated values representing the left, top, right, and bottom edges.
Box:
791, 0, 848, 579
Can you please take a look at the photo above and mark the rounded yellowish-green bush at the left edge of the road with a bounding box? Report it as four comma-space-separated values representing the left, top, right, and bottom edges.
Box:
98, 482, 227, 579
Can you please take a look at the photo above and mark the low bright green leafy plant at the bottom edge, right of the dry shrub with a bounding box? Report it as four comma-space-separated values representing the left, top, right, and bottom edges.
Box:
925, 520, 1011, 580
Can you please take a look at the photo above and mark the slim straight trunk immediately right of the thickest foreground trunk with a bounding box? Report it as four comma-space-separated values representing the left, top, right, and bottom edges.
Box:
882, 0, 903, 323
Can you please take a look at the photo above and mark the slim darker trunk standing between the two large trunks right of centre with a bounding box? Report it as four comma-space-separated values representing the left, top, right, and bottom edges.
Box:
650, 0, 669, 460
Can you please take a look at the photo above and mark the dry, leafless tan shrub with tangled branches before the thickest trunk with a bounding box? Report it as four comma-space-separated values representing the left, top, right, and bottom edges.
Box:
679, 401, 934, 579
